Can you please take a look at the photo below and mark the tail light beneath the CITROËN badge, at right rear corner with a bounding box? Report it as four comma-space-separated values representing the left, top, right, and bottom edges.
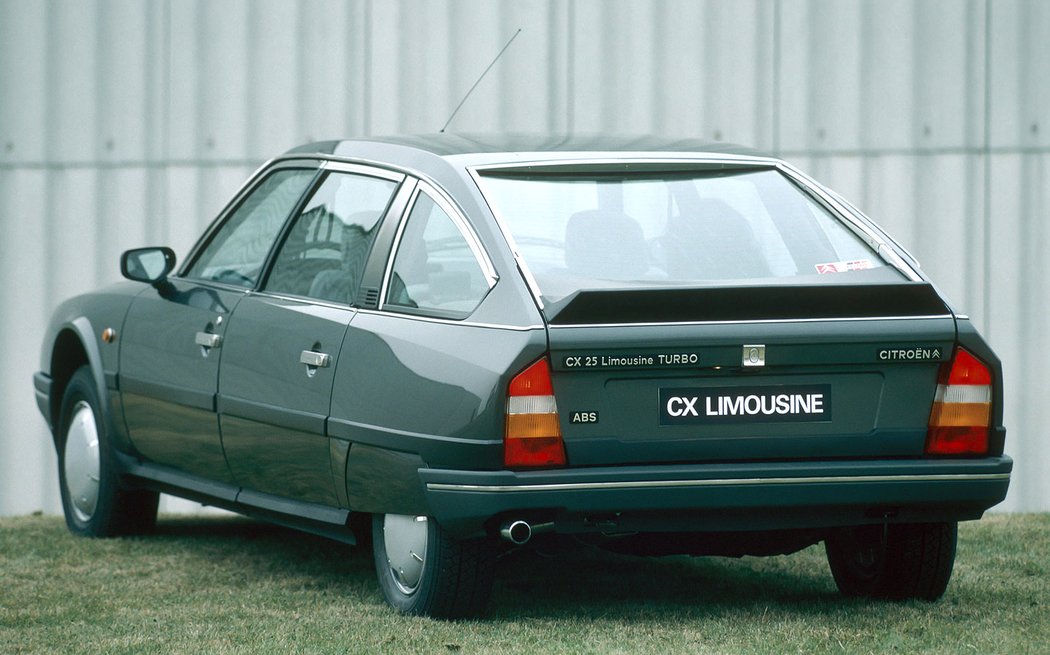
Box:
926, 347, 991, 455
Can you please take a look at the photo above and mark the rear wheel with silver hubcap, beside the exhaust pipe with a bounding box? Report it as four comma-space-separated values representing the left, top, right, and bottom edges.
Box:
372, 514, 496, 618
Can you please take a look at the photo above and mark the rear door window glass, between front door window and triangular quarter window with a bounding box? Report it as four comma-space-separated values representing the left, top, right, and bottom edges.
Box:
266, 172, 397, 304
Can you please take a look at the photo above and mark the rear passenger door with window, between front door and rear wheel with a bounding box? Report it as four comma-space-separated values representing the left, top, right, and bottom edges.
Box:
218, 164, 404, 505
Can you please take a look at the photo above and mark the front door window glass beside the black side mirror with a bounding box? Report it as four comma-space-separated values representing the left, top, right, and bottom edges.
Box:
186, 169, 314, 289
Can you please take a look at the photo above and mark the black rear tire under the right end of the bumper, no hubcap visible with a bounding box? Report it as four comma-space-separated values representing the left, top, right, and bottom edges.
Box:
824, 523, 958, 600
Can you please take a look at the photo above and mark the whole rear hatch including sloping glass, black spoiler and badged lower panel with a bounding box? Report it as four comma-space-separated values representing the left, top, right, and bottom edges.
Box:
478, 155, 956, 466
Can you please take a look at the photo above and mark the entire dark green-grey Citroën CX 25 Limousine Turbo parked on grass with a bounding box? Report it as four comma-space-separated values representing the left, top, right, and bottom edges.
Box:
34, 133, 1012, 617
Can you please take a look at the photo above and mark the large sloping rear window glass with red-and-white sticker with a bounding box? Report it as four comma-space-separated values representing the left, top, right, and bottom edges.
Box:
480, 169, 904, 300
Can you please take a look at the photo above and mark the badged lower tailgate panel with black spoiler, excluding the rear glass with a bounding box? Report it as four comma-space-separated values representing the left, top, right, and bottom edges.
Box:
545, 282, 956, 466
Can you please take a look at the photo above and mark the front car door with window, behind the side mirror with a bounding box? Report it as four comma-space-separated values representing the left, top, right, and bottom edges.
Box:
120, 164, 316, 483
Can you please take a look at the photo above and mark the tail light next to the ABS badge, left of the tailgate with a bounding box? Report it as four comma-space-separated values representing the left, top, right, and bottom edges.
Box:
503, 357, 566, 468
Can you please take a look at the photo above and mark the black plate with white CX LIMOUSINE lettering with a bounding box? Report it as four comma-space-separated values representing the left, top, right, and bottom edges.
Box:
659, 384, 832, 425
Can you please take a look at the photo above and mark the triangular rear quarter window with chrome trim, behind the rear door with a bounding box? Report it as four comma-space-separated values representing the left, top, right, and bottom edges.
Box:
386, 188, 490, 318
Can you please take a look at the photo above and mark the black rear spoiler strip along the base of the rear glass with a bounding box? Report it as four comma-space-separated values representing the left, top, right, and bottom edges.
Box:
544, 282, 951, 325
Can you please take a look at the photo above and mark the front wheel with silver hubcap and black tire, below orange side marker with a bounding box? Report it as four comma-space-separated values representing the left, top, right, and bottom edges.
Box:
55, 366, 160, 536
